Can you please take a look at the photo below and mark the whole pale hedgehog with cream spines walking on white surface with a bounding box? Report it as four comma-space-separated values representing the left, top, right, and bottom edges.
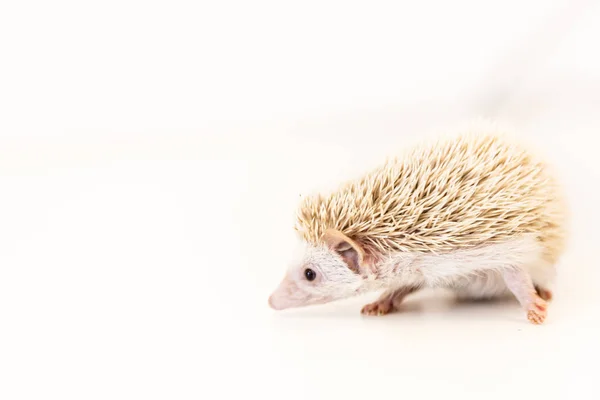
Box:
269, 133, 567, 324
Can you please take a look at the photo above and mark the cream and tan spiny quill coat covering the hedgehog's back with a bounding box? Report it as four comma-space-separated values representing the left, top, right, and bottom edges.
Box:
296, 128, 566, 290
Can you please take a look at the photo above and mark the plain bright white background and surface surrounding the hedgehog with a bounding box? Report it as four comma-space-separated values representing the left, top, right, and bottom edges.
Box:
0, 0, 600, 400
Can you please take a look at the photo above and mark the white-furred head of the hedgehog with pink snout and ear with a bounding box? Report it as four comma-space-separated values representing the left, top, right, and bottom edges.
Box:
269, 229, 368, 310
